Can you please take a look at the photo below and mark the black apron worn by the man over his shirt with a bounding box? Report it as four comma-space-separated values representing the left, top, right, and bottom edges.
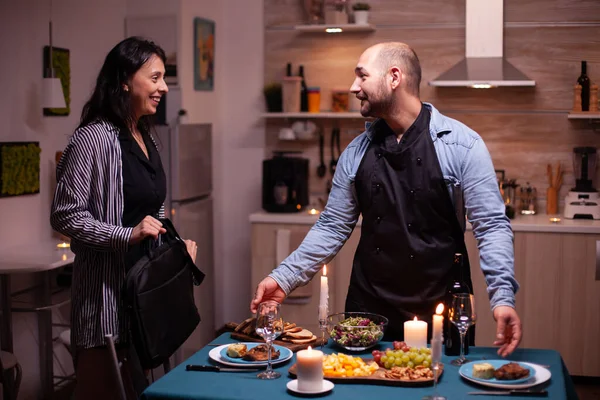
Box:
346, 106, 473, 340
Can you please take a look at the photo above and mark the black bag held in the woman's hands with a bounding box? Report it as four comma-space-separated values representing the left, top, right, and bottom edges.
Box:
125, 219, 205, 369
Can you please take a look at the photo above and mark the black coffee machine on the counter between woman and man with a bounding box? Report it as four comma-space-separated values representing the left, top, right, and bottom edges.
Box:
262, 152, 308, 213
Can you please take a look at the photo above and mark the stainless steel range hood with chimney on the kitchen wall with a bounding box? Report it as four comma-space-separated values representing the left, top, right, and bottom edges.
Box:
429, 0, 535, 88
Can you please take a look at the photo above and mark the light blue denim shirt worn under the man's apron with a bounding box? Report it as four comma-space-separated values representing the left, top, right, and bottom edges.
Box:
269, 103, 519, 309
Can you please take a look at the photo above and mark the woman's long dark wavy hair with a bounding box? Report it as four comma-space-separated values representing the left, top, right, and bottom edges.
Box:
79, 37, 167, 133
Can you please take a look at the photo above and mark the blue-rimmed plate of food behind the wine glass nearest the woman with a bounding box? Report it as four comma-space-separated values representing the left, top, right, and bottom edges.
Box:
208, 342, 293, 367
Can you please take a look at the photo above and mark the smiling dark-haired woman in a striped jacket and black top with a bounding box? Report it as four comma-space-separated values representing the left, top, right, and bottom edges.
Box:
50, 37, 197, 399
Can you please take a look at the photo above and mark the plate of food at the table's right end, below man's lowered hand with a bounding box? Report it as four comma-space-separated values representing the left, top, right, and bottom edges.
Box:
458, 360, 551, 389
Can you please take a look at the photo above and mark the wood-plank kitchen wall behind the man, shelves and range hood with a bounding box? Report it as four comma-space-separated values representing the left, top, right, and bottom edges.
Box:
264, 0, 600, 212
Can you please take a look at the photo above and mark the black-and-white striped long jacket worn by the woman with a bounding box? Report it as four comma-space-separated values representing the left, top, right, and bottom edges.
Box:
50, 121, 164, 348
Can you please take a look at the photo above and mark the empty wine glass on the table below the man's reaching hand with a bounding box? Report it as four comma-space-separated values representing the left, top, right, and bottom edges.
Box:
256, 301, 283, 379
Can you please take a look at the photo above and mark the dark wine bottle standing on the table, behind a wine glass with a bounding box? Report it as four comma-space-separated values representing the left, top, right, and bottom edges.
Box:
444, 253, 471, 356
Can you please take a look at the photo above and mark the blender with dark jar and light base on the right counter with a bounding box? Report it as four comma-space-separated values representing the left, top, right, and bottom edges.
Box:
565, 147, 600, 219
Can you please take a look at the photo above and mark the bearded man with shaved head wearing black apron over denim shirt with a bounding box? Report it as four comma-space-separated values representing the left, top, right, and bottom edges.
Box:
250, 43, 521, 357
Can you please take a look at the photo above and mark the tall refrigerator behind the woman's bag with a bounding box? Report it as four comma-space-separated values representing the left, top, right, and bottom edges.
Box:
156, 124, 215, 364
